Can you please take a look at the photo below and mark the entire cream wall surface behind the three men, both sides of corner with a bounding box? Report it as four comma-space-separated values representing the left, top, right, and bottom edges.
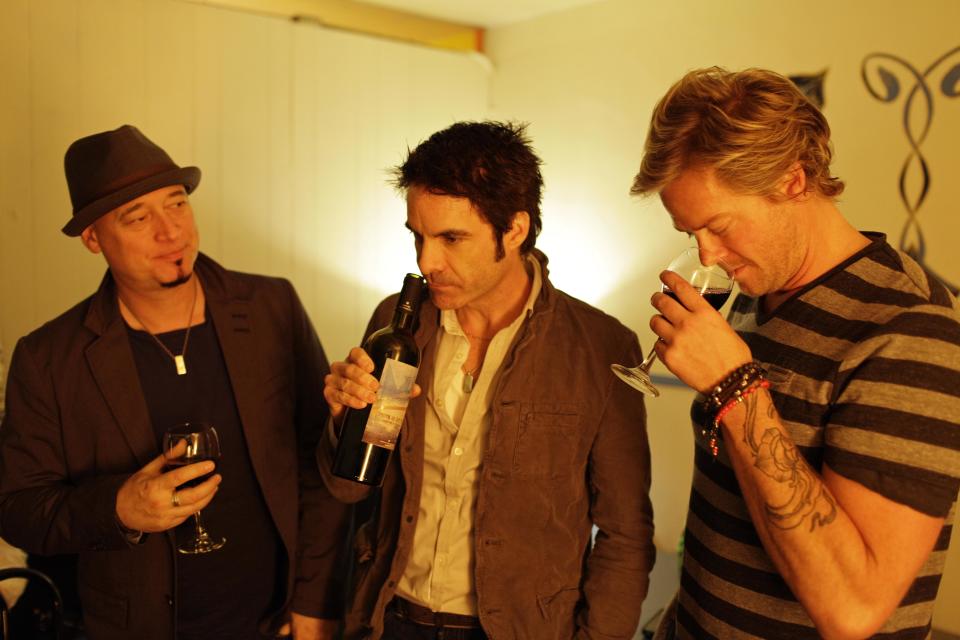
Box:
0, 0, 960, 631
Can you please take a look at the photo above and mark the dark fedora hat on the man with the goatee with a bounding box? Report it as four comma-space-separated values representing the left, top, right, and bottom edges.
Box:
63, 124, 200, 236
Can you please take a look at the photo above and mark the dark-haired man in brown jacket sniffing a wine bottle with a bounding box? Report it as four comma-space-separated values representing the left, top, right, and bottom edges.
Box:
318, 122, 654, 640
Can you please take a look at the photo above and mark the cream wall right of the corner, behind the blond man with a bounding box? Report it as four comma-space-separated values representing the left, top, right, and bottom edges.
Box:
487, 0, 960, 632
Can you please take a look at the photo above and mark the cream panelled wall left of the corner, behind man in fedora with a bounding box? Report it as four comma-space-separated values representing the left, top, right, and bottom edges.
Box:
0, 0, 489, 390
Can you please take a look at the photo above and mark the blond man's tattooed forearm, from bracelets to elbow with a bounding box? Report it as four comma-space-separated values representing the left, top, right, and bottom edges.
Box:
722, 389, 919, 637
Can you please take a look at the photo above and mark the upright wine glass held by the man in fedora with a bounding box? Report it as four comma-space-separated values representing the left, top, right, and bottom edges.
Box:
163, 422, 227, 554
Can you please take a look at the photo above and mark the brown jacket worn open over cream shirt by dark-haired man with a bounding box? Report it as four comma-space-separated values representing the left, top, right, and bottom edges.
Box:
318, 251, 654, 640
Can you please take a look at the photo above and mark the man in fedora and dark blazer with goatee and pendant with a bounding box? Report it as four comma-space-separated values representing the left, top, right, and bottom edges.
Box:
0, 125, 346, 640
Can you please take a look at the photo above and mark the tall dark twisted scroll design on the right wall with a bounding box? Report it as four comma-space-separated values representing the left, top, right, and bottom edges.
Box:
860, 47, 960, 295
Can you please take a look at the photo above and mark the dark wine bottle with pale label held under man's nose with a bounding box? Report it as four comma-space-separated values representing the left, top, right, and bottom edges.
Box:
333, 273, 427, 486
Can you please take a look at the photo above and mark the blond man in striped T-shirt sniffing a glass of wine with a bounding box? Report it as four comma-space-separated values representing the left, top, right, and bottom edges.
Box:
633, 68, 960, 638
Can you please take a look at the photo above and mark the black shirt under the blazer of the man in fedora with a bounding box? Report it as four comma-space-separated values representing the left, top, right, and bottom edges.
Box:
128, 314, 286, 640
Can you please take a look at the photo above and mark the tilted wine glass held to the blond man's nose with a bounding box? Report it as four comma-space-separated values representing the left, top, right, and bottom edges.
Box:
610, 248, 733, 397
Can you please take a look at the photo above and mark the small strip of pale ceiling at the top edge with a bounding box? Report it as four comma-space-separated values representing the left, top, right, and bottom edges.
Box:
362, 0, 598, 29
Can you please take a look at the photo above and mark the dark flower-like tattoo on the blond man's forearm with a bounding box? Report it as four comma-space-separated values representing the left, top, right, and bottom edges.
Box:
743, 395, 837, 531
